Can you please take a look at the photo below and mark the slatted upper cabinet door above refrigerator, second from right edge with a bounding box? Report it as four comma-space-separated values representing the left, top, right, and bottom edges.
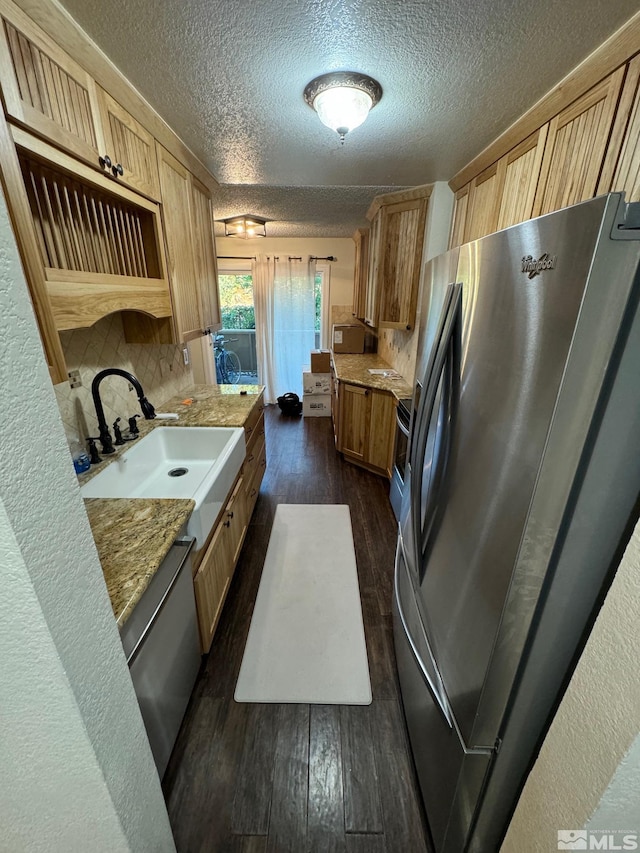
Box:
533, 68, 625, 216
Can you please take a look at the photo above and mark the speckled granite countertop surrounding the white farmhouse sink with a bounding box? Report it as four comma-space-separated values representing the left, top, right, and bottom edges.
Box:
84, 385, 264, 627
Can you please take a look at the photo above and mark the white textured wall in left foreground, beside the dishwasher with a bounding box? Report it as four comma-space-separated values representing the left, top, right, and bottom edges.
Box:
0, 183, 175, 853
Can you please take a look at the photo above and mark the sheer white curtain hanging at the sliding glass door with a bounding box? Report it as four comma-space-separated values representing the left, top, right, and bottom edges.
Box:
252, 256, 316, 403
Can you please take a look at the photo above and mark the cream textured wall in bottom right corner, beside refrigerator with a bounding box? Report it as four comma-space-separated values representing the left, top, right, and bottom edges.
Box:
501, 524, 640, 853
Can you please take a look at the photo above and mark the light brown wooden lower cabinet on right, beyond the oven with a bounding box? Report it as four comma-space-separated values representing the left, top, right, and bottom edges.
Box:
338, 383, 396, 477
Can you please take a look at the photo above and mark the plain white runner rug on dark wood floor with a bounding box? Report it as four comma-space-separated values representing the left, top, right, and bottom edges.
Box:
235, 504, 371, 705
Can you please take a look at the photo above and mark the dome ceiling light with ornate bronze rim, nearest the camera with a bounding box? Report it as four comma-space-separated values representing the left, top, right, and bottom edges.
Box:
304, 71, 382, 142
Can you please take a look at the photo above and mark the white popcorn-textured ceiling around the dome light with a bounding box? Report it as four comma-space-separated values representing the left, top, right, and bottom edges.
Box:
57, 0, 639, 235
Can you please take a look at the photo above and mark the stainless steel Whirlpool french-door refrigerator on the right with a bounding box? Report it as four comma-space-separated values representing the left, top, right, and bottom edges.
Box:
393, 194, 640, 853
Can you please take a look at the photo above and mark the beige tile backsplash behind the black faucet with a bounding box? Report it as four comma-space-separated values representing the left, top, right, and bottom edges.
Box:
54, 314, 193, 444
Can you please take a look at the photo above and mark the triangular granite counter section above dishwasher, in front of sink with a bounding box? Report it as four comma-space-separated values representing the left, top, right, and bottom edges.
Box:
84, 498, 195, 627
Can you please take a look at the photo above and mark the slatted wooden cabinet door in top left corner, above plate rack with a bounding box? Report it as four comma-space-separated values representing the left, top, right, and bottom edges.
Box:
0, 2, 104, 165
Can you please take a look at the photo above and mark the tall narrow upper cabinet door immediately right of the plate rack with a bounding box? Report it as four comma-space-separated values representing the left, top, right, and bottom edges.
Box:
157, 145, 204, 342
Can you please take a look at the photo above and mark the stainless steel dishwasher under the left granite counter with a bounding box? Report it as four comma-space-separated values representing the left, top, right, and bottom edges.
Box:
120, 539, 200, 778
